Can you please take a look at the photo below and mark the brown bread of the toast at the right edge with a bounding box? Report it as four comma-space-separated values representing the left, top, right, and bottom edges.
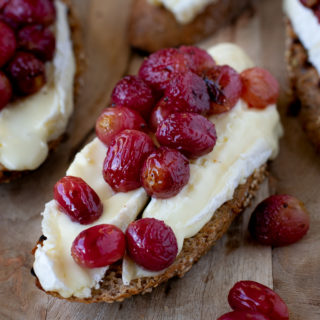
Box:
286, 19, 320, 152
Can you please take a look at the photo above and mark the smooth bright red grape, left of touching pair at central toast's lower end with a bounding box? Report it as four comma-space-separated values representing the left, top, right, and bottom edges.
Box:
71, 224, 126, 268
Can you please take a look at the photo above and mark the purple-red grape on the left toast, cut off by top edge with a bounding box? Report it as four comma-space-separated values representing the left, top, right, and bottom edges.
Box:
3, 0, 56, 26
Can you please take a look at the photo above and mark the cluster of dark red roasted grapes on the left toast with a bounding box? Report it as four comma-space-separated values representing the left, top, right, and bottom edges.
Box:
0, 0, 56, 110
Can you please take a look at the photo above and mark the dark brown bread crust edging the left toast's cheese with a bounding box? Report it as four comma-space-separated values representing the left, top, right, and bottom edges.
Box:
0, 0, 85, 183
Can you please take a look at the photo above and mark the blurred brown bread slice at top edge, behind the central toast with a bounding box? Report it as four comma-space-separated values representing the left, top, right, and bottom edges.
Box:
129, 0, 250, 52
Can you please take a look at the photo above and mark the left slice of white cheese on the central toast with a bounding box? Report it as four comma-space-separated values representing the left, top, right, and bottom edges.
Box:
33, 138, 147, 298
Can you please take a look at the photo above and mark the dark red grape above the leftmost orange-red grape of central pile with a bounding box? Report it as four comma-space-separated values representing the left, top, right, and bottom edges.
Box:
111, 76, 155, 118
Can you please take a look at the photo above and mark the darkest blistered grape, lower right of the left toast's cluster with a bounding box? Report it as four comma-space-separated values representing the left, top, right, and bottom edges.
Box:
8, 52, 46, 95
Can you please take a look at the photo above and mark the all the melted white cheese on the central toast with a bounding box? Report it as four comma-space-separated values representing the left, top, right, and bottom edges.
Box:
34, 44, 282, 298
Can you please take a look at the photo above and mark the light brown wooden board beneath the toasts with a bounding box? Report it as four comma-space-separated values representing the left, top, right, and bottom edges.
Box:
0, 0, 320, 320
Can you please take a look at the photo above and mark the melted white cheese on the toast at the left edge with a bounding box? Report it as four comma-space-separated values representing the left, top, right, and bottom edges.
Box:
0, 1, 75, 170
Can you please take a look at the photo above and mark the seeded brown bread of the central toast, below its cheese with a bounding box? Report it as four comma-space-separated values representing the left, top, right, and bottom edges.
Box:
33, 164, 267, 303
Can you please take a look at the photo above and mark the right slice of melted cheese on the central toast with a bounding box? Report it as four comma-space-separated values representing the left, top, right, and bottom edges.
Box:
122, 44, 282, 284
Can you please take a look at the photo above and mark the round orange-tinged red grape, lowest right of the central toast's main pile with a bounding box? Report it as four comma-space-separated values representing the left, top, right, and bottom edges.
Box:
141, 147, 190, 199
